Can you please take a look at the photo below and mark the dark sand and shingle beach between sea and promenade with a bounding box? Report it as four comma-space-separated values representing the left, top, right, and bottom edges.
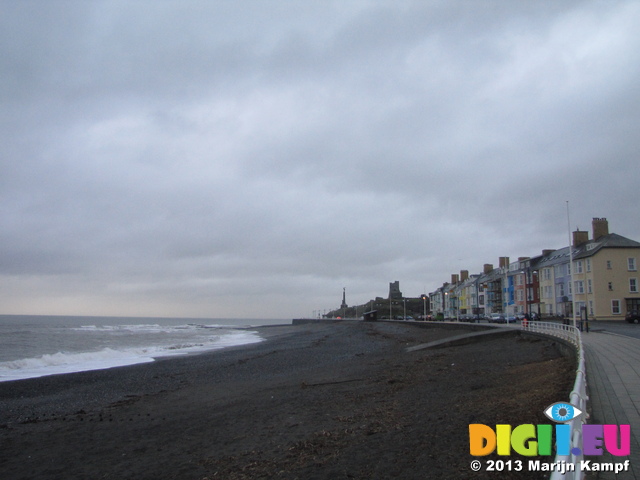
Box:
0, 322, 574, 480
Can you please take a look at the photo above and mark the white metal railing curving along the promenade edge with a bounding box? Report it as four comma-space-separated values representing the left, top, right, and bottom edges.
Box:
522, 322, 589, 480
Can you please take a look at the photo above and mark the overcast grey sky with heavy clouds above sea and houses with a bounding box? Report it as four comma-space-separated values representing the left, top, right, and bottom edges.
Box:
0, 0, 640, 318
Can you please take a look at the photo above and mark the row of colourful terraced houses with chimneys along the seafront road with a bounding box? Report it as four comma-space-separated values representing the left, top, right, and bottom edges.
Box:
429, 218, 640, 320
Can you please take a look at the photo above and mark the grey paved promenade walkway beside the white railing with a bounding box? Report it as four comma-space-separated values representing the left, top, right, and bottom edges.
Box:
582, 331, 640, 480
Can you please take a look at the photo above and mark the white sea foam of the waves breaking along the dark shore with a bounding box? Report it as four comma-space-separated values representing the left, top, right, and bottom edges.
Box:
0, 325, 263, 382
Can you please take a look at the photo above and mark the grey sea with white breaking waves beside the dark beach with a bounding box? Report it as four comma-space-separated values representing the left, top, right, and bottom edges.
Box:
0, 315, 291, 382
